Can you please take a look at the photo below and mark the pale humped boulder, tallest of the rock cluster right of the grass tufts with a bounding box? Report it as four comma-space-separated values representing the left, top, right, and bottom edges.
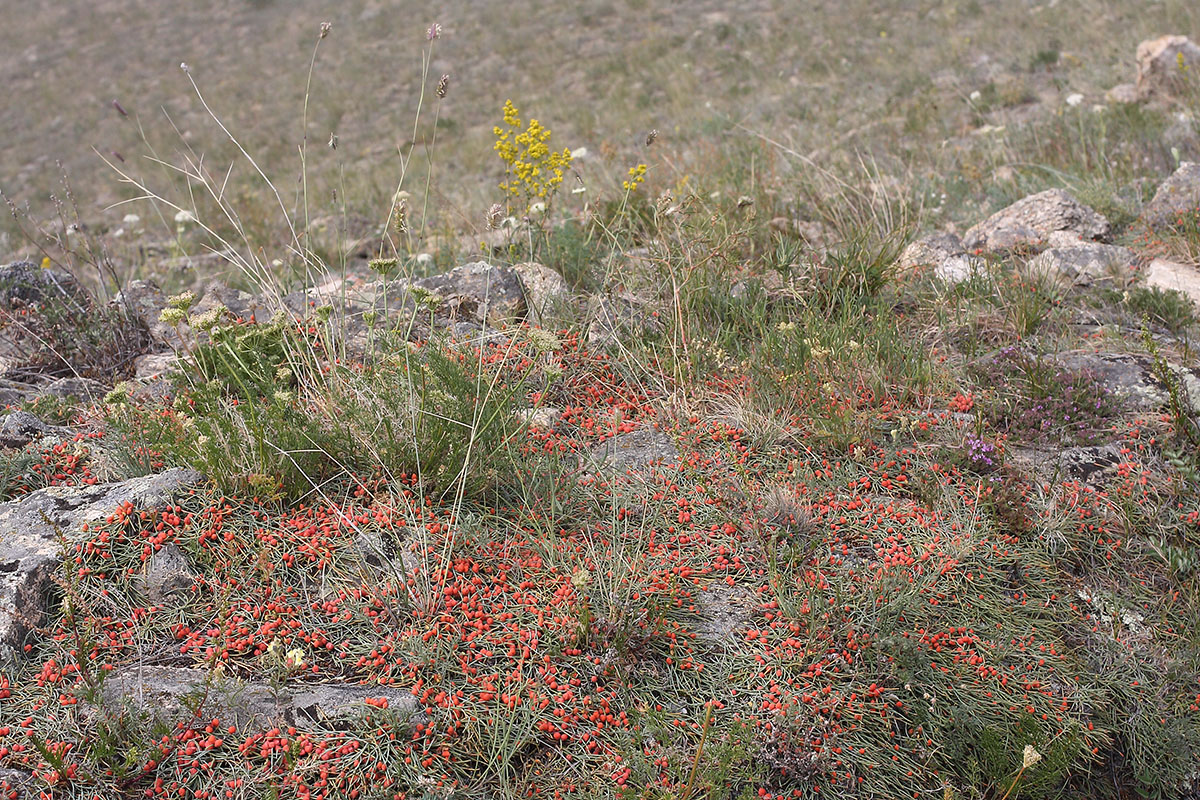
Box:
962, 188, 1111, 253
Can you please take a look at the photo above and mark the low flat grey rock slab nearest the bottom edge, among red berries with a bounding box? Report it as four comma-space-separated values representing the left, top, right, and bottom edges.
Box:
102, 666, 421, 732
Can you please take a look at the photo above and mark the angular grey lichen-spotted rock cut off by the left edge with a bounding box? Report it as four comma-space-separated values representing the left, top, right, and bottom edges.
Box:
0, 469, 204, 663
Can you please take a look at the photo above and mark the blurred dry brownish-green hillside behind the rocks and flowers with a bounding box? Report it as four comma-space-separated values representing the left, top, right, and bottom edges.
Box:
0, 0, 1200, 262
